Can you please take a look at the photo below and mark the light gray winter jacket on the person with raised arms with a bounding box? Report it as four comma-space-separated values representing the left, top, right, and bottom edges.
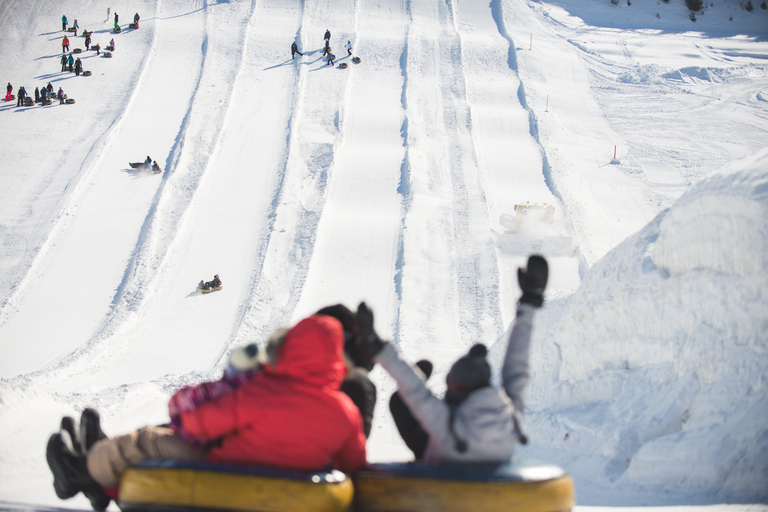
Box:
375, 304, 535, 462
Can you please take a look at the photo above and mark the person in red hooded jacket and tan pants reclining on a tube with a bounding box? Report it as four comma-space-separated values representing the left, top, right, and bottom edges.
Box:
46, 314, 366, 511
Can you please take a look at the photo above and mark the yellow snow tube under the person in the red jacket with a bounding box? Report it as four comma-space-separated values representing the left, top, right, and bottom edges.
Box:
118, 460, 353, 512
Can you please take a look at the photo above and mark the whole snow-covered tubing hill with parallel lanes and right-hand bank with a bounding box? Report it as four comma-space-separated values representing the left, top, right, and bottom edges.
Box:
0, 0, 768, 510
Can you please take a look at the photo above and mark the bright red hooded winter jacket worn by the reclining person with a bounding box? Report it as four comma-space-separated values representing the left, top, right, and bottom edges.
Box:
181, 315, 366, 472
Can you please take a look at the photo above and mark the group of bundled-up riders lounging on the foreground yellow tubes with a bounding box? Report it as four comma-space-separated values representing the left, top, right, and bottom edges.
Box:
47, 256, 548, 510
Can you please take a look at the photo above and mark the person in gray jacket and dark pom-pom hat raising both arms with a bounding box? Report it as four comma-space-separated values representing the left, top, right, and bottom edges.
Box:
357, 256, 549, 462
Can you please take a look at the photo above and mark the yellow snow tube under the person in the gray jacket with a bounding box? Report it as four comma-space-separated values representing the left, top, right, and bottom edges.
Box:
354, 462, 575, 512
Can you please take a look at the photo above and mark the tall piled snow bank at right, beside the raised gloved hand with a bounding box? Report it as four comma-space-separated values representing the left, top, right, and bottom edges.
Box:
504, 150, 768, 503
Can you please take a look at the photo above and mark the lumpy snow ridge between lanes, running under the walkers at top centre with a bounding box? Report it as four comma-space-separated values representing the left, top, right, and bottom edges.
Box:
236, 0, 355, 342
